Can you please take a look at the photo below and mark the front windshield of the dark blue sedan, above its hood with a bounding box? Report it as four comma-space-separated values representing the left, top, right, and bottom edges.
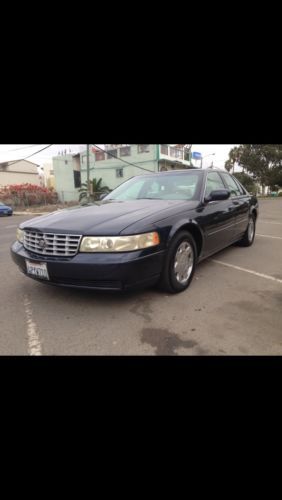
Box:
104, 170, 202, 201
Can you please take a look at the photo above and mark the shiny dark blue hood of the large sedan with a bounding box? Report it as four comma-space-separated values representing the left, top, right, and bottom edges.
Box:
20, 200, 198, 236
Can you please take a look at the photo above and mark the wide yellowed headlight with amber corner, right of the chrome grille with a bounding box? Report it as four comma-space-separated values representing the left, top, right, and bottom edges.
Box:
80, 232, 160, 252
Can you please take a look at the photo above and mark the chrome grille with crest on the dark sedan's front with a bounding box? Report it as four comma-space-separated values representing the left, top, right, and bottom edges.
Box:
24, 230, 81, 257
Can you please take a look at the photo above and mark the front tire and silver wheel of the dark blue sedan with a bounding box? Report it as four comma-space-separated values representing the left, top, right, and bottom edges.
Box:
159, 231, 197, 293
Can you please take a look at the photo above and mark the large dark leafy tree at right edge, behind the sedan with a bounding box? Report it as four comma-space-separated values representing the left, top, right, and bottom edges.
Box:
225, 144, 282, 191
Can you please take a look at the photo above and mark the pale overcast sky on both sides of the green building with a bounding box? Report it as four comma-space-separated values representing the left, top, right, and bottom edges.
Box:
0, 144, 238, 168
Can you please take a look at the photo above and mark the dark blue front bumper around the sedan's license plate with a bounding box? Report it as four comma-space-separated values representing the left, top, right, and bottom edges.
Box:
11, 241, 165, 290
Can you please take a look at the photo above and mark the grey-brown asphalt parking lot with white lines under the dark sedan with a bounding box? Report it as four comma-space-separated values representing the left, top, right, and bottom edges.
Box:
0, 199, 282, 355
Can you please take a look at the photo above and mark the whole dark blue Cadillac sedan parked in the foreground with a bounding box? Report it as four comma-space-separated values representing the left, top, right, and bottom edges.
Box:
11, 169, 258, 293
